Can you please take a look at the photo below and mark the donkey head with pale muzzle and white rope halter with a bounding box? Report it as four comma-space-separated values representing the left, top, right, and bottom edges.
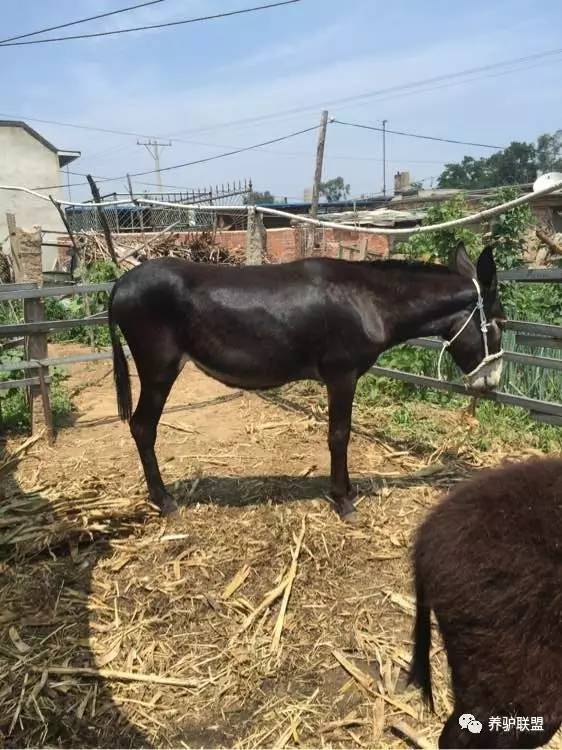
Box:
448, 244, 506, 390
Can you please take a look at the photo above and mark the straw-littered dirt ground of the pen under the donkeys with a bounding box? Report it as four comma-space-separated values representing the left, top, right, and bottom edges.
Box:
0, 345, 562, 748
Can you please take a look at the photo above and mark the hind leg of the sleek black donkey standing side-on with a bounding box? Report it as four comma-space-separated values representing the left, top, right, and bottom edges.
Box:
131, 368, 178, 515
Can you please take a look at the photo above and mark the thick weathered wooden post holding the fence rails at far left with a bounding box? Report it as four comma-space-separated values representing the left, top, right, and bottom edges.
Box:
10, 220, 54, 442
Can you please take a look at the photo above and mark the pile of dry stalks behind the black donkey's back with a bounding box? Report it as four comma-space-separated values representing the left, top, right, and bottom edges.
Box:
76, 231, 244, 270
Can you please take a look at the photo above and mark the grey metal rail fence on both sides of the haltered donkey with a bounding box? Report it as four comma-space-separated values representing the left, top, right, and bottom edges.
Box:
0, 268, 562, 434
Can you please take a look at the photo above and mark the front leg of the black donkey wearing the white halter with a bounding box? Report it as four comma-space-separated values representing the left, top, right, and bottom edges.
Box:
326, 373, 357, 522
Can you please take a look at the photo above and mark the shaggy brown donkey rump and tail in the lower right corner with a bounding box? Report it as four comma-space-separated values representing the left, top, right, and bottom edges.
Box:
410, 458, 562, 748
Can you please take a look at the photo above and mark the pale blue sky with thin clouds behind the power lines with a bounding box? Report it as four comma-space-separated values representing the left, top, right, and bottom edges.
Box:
0, 0, 562, 199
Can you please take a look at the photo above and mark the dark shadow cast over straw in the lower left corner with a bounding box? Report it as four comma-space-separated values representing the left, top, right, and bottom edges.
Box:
0, 444, 151, 748
